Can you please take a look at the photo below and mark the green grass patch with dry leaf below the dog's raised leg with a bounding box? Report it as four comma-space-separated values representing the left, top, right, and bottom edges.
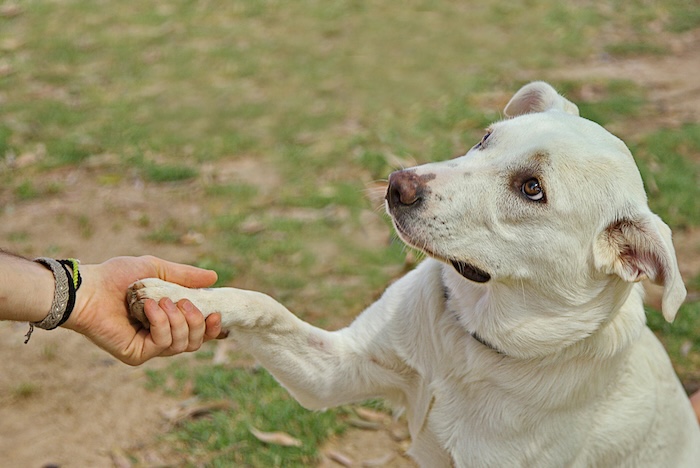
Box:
148, 366, 345, 467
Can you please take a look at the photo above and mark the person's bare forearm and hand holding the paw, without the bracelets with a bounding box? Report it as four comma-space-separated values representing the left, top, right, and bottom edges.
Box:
0, 252, 221, 365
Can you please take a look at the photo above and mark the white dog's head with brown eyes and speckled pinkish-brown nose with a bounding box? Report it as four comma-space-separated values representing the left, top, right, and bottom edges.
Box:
386, 82, 685, 340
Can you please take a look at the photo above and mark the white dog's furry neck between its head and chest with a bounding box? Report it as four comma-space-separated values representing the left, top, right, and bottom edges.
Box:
442, 266, 645, 359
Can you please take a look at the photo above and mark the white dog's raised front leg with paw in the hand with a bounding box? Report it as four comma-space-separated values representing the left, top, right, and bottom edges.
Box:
128, 278, 400, 409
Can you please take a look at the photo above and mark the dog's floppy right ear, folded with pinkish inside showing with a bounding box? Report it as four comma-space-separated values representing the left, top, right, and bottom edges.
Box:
594, 213, 686, 322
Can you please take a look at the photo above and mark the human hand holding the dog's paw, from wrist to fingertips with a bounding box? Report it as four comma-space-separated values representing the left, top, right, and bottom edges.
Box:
63, 256, 221, 365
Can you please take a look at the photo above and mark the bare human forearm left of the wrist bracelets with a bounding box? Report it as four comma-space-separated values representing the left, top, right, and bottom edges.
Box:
0, 251, 55, 322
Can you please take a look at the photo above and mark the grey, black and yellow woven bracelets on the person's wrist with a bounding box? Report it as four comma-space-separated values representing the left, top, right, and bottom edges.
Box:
24, 257, 82, 344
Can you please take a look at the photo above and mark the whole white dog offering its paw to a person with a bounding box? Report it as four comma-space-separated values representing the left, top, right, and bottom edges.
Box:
129, 82, 700, 468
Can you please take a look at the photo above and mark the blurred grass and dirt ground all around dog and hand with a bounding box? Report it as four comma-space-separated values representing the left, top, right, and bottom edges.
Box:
0, 0, 700, 466
